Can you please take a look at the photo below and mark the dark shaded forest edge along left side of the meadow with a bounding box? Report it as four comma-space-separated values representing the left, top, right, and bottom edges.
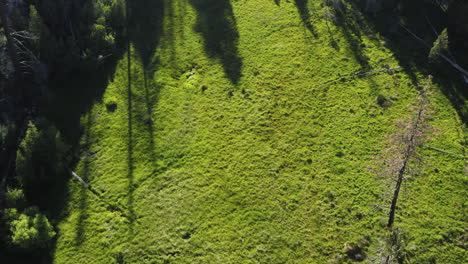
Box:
0, 0, 126, 262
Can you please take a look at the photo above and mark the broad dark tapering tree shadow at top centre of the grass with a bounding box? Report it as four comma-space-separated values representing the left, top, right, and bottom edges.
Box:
190, 0, 242, 84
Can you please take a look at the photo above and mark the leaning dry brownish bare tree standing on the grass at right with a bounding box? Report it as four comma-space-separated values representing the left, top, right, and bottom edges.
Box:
373, 76, 433, 264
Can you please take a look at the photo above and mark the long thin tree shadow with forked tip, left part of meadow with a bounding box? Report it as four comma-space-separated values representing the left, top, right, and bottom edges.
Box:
126, 0, 166, 235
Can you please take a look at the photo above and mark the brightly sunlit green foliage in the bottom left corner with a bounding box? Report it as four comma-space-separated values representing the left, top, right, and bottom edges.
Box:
4, 207, 55, 250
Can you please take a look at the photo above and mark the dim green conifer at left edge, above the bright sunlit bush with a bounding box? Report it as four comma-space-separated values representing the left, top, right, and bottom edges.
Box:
16, 122, 69, 190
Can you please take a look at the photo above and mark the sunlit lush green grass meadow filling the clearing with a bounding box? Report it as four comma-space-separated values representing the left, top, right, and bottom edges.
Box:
53, 0, 467, 263
